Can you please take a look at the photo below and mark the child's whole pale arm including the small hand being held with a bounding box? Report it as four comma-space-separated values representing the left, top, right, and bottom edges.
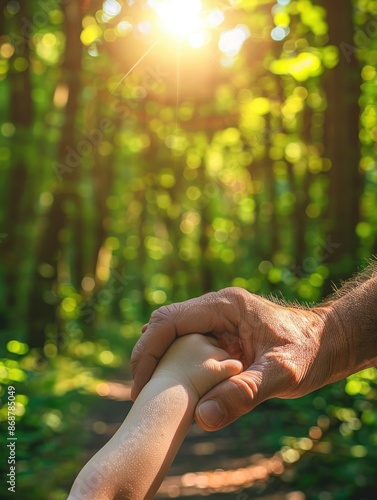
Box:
68, 334, 243, 500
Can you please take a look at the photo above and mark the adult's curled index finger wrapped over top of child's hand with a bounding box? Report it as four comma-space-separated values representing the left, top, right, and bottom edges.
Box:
131, 291, 239, 399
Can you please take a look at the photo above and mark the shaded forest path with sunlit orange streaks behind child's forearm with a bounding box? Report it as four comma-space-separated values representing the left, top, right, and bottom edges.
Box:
83, 379, 305, 500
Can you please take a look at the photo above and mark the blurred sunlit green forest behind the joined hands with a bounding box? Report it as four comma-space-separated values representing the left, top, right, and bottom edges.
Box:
0, 0, 377, 500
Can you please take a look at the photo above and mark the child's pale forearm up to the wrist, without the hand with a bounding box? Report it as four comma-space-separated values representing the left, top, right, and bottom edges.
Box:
68, 377, 198, 500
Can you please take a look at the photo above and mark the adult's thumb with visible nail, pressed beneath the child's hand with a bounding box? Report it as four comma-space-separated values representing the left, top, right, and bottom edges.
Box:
195, 365, 273, 431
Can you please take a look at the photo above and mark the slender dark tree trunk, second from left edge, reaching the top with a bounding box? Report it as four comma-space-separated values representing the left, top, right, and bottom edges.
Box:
27, 2, 83, 347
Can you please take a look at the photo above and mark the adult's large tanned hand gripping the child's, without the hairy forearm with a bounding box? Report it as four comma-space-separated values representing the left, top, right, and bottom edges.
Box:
131, 288, 353, 431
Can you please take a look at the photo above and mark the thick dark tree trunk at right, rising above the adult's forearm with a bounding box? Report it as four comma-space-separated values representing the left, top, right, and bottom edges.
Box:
320, 0, 361, 291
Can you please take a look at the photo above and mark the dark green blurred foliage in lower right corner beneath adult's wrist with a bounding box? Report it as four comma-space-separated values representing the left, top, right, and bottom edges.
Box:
238, 369, 377, 499
